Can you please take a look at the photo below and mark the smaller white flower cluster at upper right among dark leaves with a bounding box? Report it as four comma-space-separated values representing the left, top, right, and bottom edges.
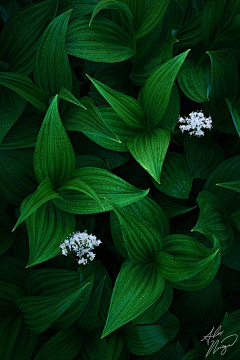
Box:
178, 111, 212, 136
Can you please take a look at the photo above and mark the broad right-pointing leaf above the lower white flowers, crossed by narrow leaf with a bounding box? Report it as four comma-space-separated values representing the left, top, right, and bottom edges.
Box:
53, 167, 148, 215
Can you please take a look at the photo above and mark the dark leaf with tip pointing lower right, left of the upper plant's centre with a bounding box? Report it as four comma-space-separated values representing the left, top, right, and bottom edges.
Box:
62, 96, 120, 143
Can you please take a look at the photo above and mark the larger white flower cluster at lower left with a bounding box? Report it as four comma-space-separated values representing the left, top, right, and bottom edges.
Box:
60, 230, 101, 265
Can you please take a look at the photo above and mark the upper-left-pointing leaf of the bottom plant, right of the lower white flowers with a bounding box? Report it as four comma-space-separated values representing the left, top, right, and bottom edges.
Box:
111, 203, 162, 263
